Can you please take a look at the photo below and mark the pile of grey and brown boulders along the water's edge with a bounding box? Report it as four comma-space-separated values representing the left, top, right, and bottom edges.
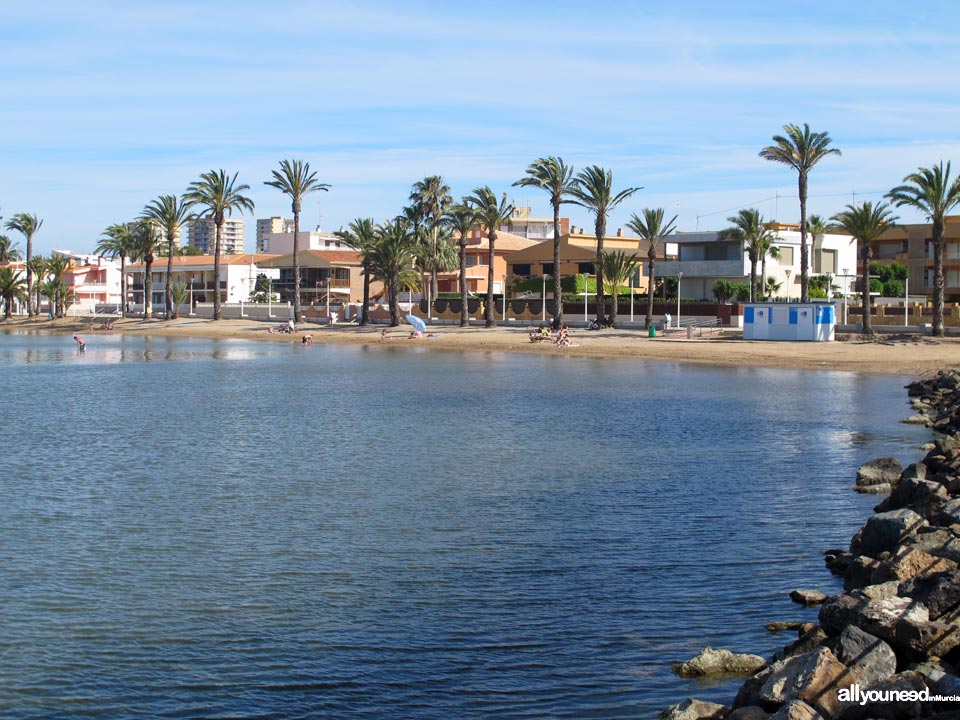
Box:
660, 371, 960, 720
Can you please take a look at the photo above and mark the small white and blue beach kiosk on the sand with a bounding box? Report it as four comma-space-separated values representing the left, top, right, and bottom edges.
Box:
743, 302, 837, 342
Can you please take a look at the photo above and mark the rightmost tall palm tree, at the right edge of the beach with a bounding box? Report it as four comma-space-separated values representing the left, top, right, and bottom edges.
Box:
886, 160, 960, 337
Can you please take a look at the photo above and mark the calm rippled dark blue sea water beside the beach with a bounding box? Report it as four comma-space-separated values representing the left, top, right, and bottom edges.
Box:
0, 335, 927, 719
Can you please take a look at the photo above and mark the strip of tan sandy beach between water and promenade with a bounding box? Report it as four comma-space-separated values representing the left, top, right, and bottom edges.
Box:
0, 318, 960, 377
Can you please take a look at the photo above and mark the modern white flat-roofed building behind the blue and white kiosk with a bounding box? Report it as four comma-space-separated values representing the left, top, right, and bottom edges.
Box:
656, 224, 857, 300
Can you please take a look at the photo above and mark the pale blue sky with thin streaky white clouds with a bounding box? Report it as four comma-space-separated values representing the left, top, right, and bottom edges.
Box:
0, 0, 960, 253
